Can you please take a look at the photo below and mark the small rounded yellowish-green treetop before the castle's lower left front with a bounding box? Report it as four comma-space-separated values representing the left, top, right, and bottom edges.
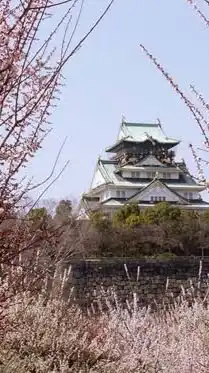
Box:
113, 203, 140, 226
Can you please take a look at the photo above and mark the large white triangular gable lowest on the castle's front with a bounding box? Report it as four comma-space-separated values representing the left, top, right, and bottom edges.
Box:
128, 180, 186, 204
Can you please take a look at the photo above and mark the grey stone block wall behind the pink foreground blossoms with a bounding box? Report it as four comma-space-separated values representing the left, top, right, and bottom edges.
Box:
65, 257, 209, 308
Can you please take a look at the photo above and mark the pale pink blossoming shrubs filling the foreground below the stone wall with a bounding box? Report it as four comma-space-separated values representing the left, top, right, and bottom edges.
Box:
0, 268, 209, 373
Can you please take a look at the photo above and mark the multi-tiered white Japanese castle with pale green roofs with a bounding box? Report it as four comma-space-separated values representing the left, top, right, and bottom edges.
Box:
81, 120, 209, 215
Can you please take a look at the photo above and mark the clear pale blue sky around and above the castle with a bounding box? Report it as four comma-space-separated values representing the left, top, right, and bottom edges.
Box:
29, 0, 209, 200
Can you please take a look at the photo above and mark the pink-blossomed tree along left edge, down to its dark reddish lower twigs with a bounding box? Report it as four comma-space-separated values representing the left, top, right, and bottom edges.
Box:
0, 0, 114, 318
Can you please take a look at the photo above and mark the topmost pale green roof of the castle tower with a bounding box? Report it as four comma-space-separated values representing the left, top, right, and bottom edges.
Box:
107, 122, 180, 151
